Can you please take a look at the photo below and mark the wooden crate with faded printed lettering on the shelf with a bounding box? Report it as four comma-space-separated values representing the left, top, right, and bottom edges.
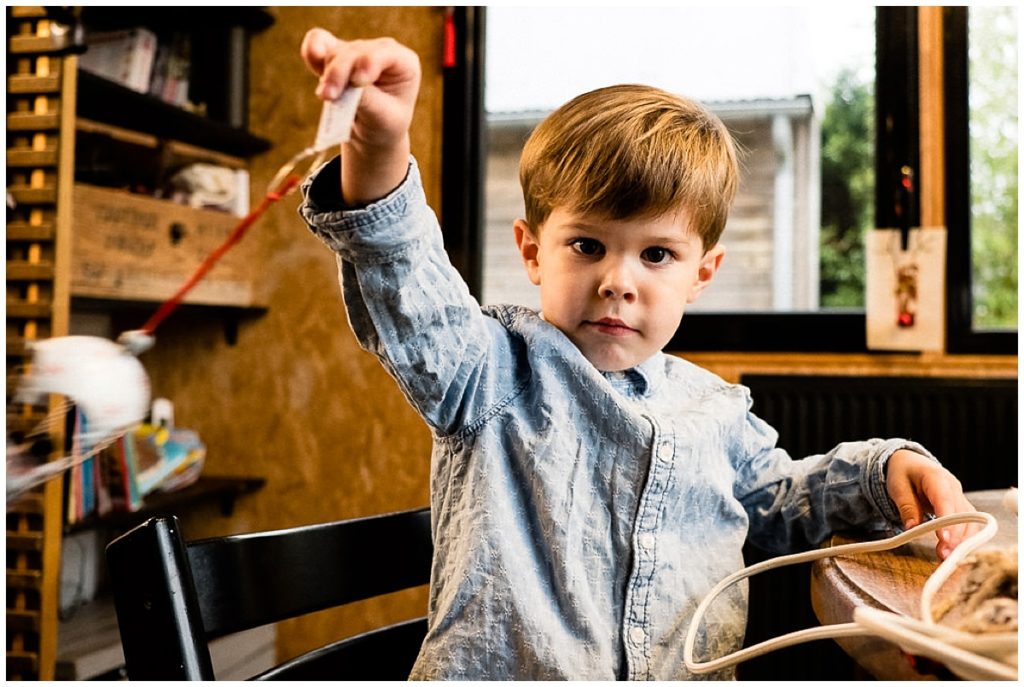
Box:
71, 183, 255, 307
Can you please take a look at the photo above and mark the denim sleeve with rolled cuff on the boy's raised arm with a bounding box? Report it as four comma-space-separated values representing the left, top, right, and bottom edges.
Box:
299, 158, 515, 434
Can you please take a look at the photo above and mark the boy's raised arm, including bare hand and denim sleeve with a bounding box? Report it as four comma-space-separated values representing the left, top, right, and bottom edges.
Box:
300, 29, 515, 433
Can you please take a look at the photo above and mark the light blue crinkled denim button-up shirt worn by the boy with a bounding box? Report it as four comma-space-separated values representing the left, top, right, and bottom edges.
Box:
300, 159, 928, 680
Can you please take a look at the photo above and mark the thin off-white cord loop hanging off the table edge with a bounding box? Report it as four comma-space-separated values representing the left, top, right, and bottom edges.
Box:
683, 512, 999, 676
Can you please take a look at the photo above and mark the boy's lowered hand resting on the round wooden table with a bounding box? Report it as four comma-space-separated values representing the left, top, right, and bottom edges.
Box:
886, 448, 976, 559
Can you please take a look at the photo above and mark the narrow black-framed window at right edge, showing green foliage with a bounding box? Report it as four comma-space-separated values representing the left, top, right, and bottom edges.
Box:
943, 6, 1018, 353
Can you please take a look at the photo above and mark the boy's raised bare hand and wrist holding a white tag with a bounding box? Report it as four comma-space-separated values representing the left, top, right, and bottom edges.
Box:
301, 29, 420, 205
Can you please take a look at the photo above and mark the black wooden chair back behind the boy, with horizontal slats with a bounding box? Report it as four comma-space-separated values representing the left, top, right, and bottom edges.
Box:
106, 509, 433, 680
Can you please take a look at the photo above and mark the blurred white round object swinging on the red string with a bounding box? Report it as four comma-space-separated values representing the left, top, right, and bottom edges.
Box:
16, 336, 150, 444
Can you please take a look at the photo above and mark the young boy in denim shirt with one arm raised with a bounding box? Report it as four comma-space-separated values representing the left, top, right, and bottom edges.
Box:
301, 30, 973, 680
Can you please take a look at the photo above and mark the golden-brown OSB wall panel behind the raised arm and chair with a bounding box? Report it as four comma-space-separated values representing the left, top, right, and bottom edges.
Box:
133, 7, 443, 659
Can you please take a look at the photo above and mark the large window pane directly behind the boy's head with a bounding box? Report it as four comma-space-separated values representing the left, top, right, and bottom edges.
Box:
482, 5, 874, 319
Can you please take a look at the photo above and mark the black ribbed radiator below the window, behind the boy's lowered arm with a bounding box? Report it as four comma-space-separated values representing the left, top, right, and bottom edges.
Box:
738, 375, 1018, 680
